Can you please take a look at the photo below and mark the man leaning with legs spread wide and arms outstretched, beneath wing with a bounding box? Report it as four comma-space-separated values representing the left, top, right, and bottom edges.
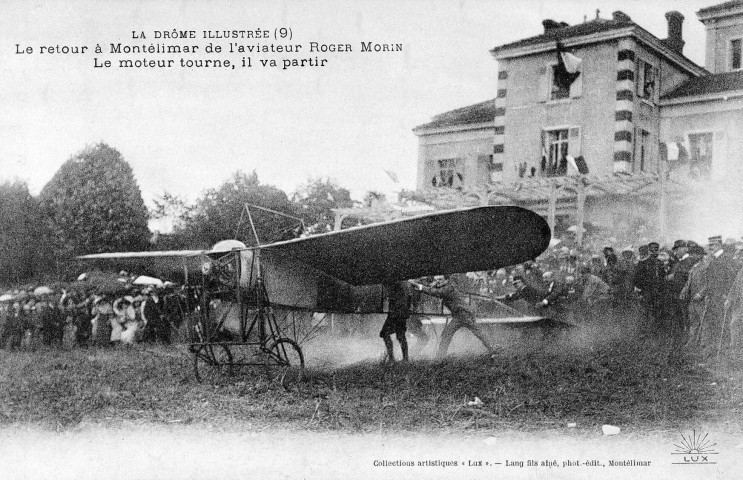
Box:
414, 275, 495, 358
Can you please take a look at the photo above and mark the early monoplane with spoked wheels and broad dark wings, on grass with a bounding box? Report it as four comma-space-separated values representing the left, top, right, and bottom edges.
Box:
79, 206, 551, 380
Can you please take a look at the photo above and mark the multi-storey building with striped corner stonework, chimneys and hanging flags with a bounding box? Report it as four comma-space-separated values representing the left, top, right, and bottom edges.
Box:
414, 0, 743, 240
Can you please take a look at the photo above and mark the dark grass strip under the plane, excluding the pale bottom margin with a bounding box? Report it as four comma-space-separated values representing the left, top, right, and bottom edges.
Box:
0, 324, 743, 436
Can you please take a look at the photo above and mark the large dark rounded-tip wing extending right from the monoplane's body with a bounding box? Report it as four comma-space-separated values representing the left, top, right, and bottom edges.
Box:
260, 206, 551, 285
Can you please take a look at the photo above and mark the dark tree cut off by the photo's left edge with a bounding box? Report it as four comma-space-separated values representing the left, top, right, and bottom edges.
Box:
0, 180, 52, 284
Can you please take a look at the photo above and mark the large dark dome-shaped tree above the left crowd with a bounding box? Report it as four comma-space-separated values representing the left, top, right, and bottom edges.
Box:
40, 143, 150, 260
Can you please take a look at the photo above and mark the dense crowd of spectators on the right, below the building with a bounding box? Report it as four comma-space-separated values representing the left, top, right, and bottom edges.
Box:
472, 230, 743, 358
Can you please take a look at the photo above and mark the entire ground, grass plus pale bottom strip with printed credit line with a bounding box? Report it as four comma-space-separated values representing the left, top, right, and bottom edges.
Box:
0, 325, 743, 479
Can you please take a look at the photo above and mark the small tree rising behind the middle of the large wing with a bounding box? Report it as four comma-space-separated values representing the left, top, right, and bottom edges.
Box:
292, 178, 353, 232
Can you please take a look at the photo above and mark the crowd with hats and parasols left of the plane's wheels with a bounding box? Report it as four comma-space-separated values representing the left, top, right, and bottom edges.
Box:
0, 272, 190, 350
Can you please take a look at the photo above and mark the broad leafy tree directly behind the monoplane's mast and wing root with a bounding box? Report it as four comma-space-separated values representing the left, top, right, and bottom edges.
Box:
174, 171, 296, 248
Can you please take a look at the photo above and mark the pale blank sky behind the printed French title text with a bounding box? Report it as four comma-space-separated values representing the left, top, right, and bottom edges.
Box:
0, 0, 720, 213
